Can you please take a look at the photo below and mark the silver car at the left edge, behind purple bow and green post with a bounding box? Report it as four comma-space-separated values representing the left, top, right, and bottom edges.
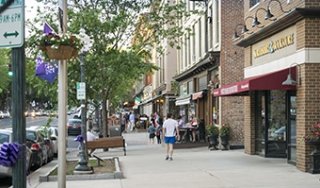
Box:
0, 129, 32, 178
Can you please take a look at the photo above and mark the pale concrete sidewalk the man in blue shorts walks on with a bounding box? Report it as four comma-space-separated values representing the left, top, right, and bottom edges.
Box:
31, 133, 320, 188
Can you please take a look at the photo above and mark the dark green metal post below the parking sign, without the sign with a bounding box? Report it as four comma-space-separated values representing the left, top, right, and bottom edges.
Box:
12, 46, 27, 188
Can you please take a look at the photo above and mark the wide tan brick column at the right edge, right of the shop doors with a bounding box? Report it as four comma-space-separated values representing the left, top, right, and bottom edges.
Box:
296, 63, 320, 171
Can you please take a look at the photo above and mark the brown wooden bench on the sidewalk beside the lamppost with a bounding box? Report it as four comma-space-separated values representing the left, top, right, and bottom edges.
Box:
87, 136, 126, 155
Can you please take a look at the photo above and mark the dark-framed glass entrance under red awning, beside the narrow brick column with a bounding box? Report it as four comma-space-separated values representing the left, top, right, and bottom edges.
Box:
255, 90, 288, 158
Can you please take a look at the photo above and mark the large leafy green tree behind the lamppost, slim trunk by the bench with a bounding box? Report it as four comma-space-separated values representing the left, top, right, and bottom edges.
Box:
29, 0, 192, 136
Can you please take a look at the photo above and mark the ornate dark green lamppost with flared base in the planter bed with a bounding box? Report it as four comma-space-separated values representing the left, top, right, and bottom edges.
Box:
74, 54, 92, 174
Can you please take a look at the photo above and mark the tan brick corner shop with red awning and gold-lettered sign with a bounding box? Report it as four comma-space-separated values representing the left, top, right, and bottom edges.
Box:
213, 0, 320, 173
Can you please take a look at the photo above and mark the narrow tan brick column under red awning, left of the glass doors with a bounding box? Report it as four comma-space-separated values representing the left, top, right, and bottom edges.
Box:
244, 93, 255, 155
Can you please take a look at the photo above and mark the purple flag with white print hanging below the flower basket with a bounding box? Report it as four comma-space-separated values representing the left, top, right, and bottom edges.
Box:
36, 57, 58, 84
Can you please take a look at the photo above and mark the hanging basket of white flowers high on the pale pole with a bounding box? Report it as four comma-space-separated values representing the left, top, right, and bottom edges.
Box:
37, 33, 83, 60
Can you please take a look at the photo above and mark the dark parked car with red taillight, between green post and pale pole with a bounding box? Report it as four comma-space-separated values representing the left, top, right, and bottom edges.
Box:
26, 127, 53, 169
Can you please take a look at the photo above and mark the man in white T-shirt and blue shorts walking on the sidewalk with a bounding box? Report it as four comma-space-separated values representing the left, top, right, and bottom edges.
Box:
162, 113, 180, 161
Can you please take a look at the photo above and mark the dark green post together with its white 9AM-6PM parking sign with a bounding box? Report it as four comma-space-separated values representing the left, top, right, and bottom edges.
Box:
0, 0, 27, 188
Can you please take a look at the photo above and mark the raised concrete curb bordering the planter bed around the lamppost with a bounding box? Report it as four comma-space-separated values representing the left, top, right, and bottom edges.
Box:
39, 157, 123, 183
